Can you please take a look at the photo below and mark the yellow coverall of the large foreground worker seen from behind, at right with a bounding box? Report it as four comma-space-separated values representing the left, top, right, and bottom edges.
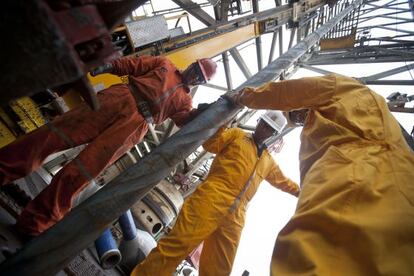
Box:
236, 75, 414, 276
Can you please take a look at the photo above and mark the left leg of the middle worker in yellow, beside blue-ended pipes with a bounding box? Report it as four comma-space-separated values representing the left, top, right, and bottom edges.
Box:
131, 182, 230, 276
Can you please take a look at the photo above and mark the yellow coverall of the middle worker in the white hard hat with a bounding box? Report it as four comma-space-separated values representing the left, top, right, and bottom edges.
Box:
131, 128, 299, 276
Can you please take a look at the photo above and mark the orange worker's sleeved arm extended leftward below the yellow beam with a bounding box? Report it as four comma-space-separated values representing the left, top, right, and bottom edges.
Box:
111, 56, 165, 76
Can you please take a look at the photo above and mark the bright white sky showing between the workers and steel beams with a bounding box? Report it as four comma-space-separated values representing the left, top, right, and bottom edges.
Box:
134, 0, 414, 276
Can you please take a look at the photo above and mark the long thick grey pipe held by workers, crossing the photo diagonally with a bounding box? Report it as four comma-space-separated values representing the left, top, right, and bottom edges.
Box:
0, 0, 362, 275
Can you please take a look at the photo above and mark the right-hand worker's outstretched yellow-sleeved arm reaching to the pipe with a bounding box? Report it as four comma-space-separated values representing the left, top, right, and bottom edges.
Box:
235, 75, 336, 111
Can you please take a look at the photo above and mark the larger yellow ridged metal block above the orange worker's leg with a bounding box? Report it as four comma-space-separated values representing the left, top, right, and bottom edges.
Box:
10, 97, 46, 133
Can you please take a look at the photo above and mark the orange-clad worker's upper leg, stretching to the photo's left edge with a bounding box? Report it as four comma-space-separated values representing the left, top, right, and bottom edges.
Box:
0, 86, 134, 185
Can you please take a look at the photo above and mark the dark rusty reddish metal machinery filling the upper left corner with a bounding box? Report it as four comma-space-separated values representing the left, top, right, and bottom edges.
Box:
0, 0, 145, 109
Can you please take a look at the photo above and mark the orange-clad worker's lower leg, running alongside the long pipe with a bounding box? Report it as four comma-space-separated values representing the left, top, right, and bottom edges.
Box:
17, 103, 147, 236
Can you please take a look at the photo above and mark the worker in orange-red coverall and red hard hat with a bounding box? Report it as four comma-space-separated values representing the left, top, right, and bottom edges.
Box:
0, 56, 217, 237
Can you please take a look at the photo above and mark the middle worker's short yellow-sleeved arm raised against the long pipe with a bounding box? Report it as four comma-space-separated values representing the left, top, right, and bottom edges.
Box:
203, 126, 244, 153
